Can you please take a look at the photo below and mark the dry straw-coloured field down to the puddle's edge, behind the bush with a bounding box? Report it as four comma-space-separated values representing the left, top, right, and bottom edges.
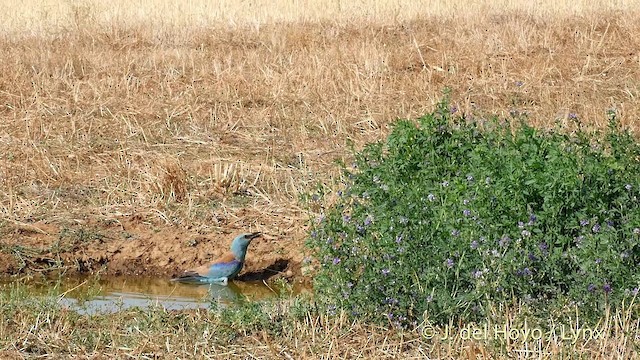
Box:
0, 0, 640, 278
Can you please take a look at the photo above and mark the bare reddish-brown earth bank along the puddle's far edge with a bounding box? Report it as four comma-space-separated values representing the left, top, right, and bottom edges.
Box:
0, 216, 308, 282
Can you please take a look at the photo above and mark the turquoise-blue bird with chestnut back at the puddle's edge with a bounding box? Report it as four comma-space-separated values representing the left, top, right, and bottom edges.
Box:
171, 232, 261, 285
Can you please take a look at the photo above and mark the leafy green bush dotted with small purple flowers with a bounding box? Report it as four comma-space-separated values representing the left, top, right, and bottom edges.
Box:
308, 102, 640, 325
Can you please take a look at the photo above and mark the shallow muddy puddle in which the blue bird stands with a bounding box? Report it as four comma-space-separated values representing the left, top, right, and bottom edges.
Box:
0, 276, 298, 314
